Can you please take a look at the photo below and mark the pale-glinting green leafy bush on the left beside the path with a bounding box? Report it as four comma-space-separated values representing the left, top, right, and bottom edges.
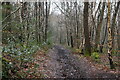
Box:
2, 41, 39, 78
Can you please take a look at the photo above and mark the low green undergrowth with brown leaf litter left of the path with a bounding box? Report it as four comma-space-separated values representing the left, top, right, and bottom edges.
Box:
2, 41, 52, 78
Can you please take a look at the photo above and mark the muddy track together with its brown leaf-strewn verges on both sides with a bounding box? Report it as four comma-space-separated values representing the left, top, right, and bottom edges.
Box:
19, 45, 120, 78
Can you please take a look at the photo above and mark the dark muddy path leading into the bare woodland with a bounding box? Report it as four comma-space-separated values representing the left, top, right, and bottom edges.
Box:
43, 45, 118, 78
